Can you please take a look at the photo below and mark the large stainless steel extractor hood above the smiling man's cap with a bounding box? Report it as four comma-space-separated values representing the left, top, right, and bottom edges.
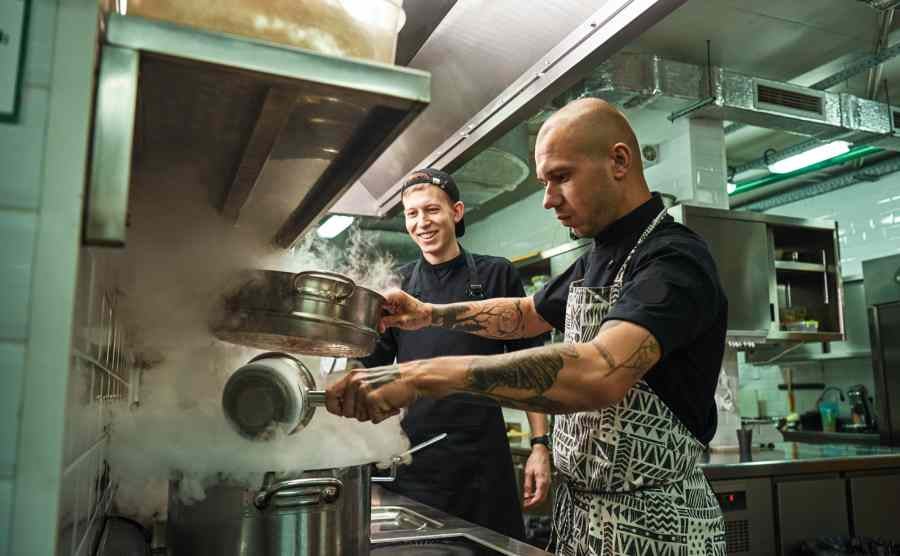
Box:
332, 0, 685, 217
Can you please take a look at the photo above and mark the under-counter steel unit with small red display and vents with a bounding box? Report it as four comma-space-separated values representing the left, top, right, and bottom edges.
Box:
710, 477, 775, 556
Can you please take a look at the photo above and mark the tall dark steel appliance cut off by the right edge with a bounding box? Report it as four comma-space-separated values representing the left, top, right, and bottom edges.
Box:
862, 255, 900, 446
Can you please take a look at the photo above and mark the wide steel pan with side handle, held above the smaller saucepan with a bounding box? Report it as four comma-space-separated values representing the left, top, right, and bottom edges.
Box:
219, 270, 385, 357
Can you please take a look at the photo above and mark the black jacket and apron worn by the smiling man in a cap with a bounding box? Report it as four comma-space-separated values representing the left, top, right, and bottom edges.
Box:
361, 247, 540, 539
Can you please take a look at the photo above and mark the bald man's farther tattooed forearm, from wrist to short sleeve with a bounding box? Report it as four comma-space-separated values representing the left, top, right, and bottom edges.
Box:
431, 297, 551, 340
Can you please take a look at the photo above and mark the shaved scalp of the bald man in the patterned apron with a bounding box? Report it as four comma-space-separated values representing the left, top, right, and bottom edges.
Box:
537, 98, 642, 170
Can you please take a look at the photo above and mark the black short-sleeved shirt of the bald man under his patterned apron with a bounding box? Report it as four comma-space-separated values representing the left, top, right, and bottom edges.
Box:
534, 194, 728, 443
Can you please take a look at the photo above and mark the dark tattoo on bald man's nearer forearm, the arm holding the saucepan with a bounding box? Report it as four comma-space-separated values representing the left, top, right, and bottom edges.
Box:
466, 344, 579, 413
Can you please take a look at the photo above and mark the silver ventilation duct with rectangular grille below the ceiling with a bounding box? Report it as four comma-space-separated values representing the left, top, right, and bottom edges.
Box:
588, 52, 900, 151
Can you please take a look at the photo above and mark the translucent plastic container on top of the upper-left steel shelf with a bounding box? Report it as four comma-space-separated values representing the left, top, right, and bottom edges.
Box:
107, 0, 406, 64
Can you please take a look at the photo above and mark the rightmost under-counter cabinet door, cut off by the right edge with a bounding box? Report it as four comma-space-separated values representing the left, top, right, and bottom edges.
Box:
848, 470, 900, 542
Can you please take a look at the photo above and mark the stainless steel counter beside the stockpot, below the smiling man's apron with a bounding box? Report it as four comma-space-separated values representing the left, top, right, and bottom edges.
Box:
372, 485, 550, 556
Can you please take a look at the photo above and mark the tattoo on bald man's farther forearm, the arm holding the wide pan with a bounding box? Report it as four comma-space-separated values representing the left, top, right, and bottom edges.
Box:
431, 299, 525, 339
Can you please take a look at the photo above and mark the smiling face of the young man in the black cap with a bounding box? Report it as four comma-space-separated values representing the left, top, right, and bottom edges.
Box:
403, 184, 465, 264
